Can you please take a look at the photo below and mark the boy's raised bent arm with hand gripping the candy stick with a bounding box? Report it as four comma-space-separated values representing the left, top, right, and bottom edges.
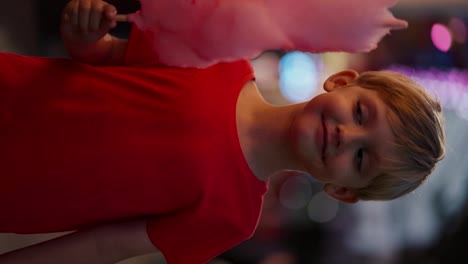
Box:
60, 0, 127, 65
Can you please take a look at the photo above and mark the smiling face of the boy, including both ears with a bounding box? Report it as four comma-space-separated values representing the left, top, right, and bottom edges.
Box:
293, 71, 394, 202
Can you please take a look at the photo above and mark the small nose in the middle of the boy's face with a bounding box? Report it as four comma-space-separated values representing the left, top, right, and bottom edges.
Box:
335, 125, 368, 152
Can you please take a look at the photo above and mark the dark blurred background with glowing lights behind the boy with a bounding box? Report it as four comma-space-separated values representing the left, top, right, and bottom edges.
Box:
0, 0, 468, 264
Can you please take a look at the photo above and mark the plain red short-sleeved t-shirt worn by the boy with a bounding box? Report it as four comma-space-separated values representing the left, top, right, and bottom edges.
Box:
0, 25, 266, 264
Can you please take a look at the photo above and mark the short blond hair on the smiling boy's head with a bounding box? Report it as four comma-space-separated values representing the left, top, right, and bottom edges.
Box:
353, 71, 445, 200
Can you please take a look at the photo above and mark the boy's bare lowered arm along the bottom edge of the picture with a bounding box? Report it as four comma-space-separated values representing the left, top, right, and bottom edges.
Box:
0, 221, 158, 264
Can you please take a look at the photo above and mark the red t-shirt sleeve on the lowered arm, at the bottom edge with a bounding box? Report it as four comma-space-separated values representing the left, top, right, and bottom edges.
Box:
147, 206, 254, 264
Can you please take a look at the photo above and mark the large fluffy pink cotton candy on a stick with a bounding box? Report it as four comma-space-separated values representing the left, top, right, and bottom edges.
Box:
129, 0, 407, 67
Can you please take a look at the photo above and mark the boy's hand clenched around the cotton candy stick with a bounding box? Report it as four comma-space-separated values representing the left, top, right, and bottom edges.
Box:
61, 0, 117, 43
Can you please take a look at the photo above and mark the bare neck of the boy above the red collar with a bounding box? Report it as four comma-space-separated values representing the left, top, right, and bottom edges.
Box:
237, 82, 304, 181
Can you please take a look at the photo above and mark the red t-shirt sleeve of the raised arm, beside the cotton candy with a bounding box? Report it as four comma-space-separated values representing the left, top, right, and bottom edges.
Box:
124, 25, 162, 67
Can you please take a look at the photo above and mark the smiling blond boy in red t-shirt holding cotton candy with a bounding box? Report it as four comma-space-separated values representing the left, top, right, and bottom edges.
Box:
0, 0, 443, 264
